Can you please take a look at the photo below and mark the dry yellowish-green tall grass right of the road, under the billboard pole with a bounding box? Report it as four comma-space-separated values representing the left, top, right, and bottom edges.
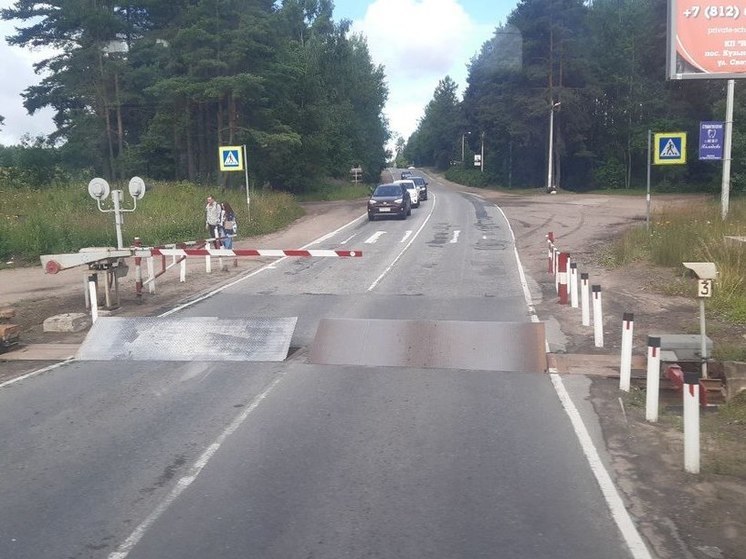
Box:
607, 199, 746, 324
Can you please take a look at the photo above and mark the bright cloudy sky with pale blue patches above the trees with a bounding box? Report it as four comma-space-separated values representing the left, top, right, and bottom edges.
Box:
0, 0, 519, 145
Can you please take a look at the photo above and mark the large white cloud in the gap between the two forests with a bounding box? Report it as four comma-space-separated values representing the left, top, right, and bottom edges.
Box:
352, 0, 497, 140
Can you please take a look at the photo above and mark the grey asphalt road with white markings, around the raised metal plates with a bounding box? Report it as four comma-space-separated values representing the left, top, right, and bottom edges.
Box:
0, 173, 632, 559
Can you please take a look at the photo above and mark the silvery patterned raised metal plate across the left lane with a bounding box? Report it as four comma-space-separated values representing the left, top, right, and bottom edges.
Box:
76, 317, 298, 361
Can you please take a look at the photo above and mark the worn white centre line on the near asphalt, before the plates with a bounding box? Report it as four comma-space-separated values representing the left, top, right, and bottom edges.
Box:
109, 374, 285, 559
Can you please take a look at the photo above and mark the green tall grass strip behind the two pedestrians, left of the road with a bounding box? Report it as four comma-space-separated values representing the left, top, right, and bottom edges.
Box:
0, 182, 303, 265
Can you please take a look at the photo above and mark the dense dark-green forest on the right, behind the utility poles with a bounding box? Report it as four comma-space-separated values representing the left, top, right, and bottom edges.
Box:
398, 0, 746, 190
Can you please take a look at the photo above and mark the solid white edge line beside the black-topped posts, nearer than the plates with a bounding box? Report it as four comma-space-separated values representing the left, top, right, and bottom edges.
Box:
550, 373, 652, 559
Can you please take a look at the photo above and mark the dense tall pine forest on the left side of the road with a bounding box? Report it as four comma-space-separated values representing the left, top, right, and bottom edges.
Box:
0, 0, 389, 192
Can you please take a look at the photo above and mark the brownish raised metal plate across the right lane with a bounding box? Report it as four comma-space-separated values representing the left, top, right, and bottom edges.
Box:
309, 318, 547, 372
